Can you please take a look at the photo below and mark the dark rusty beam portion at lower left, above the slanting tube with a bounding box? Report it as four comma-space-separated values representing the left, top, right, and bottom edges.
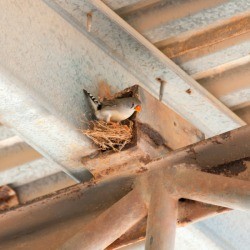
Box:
0, 178, 136, 249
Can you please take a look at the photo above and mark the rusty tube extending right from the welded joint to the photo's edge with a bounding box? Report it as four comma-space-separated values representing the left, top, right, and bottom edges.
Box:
163, 164, 250, 211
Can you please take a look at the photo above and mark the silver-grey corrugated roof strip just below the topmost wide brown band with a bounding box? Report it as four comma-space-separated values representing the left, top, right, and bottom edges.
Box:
126, 0, 250, 43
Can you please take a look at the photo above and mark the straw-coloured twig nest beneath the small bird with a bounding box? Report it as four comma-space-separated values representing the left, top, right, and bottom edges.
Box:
83, 120, 133, 151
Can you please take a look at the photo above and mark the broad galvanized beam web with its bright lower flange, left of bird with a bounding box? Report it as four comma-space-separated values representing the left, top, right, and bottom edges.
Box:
0, 1, 141, 180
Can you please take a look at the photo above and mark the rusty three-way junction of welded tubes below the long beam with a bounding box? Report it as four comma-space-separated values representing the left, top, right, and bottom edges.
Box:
62, 160, 250, 250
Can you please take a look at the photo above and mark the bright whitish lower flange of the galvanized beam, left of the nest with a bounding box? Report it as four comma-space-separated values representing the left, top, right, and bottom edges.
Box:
0, 68, 93, 182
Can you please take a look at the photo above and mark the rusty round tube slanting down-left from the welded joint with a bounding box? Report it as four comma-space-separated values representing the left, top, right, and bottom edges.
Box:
60, 189, 147, 250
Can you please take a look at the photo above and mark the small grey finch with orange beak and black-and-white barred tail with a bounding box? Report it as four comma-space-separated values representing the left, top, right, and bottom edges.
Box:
83, 89, 141, 123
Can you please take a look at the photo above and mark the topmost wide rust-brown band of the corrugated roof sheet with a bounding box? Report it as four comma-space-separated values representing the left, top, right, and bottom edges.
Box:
124, 0, 225, 43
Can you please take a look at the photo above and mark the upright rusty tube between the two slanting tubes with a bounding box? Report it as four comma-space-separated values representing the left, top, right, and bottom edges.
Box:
146, 171, 178, 250
